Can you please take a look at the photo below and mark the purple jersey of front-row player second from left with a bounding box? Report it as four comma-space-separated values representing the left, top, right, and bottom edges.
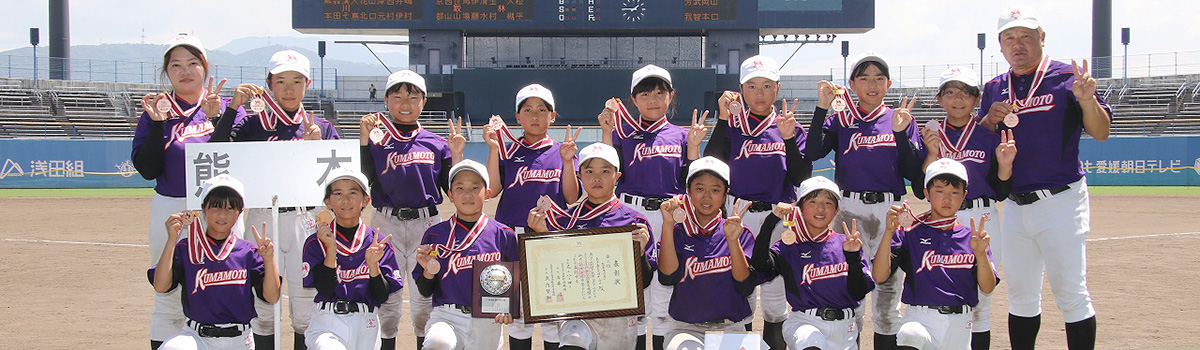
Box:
301, 223, 403, 307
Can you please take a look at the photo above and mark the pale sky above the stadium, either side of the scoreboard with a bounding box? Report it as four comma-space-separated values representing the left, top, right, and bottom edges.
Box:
0, 0, 1200, 76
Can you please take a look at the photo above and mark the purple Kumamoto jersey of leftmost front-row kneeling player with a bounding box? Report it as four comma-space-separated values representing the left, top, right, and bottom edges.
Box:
149, 234, 264, 325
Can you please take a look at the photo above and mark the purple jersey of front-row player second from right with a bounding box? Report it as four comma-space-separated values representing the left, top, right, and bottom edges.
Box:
770, 233, 875, 312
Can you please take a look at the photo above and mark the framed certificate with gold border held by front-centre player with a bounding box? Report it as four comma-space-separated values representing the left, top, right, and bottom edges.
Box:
518, 225, 646, 324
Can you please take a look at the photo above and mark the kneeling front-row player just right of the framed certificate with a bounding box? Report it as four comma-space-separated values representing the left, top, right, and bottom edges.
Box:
658, 157, 760, 350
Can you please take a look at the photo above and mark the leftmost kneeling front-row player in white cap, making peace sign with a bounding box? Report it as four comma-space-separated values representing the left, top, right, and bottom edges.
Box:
149, 175, 281, 350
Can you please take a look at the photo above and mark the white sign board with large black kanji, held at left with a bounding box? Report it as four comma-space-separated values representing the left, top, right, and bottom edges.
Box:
185, 140, 361, 210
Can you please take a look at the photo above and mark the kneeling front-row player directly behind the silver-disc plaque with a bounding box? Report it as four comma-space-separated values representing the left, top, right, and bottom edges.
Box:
413, 159, 520, 350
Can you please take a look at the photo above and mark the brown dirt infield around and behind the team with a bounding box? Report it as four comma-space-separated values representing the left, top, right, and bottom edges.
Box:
0, 195, 1200, 349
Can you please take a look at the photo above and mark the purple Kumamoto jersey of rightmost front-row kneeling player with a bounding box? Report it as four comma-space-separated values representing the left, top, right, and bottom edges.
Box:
892, 224, 998, 307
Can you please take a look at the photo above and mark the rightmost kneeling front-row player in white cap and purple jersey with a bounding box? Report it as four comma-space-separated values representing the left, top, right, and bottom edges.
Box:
872, 158, 1000, 349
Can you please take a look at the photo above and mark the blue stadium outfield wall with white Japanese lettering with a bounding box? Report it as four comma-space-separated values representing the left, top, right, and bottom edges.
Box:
0, 137, 1200, 188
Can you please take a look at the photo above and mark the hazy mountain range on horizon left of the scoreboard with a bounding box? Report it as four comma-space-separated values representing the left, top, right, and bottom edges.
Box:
0, 37, 408, 76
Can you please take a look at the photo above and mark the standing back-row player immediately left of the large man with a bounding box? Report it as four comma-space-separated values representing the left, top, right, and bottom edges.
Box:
922, 67, 1016, 350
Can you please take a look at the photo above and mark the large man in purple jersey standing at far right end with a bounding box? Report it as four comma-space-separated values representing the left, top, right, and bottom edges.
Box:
980, 8, 1112, 350
